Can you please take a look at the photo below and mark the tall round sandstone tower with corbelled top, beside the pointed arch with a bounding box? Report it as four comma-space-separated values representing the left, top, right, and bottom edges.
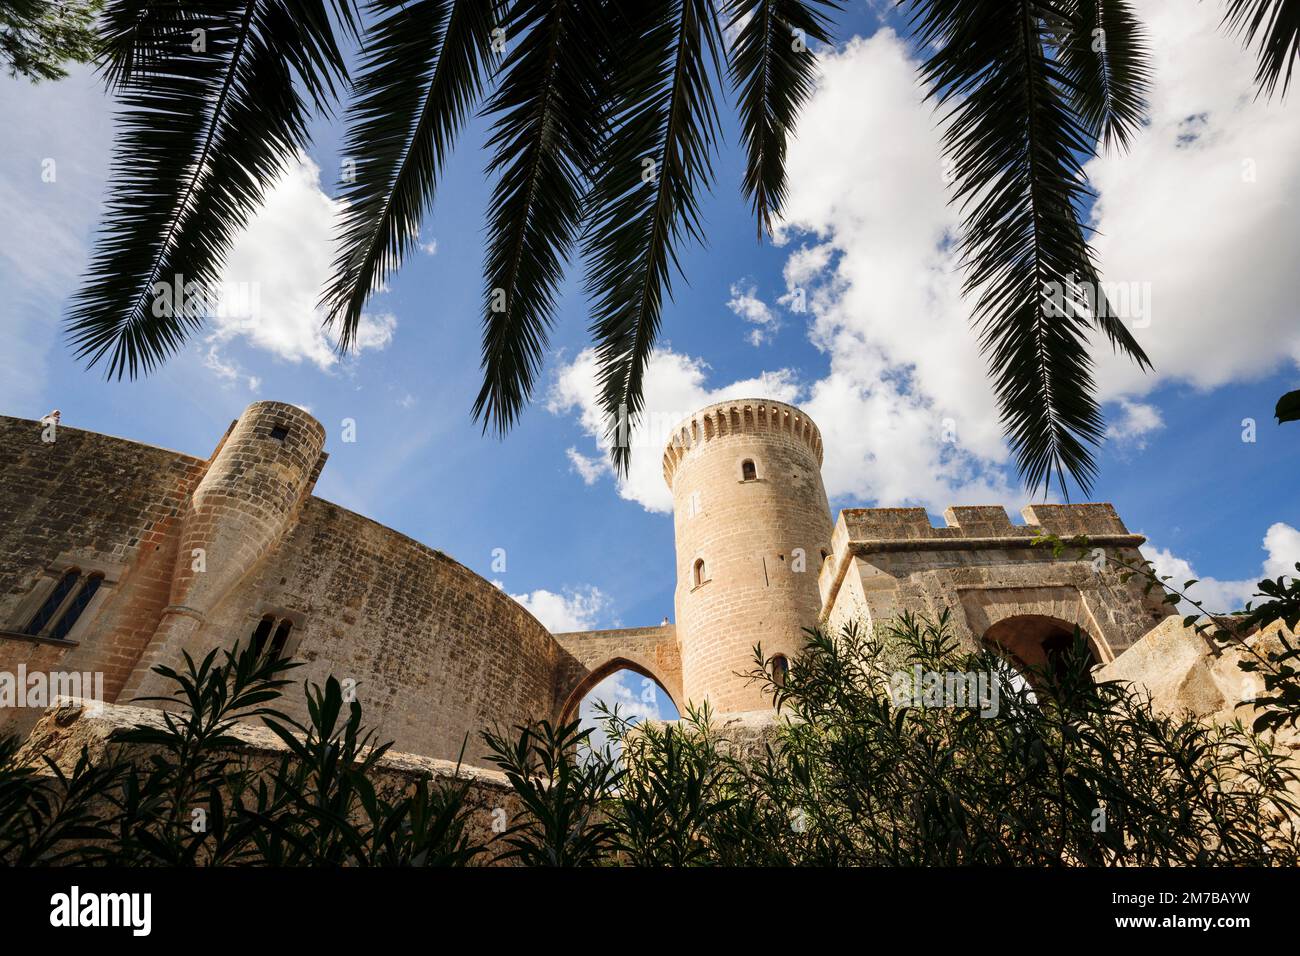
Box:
663, 398, 831, 713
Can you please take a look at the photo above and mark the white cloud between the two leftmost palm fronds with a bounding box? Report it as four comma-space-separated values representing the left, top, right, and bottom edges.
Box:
209, 156, 397, 369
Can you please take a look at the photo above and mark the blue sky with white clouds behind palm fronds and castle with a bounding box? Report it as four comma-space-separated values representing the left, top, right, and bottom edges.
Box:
0, 0, 1300, 711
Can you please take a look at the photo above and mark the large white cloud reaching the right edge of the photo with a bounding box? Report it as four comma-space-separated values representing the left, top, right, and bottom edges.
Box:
1087, 0, 1300, 397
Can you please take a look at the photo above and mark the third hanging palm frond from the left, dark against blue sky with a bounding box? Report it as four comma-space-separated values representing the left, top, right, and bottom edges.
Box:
473, 0, 610, 434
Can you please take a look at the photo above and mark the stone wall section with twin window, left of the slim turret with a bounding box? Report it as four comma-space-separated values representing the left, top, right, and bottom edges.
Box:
0, 418, 207, 732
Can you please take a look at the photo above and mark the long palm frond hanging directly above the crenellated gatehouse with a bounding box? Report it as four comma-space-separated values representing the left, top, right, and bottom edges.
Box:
914, 0, 1145, 502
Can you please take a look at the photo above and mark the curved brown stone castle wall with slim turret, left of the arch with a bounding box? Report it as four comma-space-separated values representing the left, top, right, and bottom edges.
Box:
0, 402, 560, 762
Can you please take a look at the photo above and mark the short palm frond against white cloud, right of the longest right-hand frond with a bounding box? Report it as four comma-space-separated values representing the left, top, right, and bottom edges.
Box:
1056, 0, 1151, 150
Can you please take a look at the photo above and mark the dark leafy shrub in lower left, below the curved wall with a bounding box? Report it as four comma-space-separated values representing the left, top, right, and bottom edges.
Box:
0, 645, 484, 866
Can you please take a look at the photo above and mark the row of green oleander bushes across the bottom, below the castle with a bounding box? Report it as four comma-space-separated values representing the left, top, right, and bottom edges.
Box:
0, 614, 1300, 866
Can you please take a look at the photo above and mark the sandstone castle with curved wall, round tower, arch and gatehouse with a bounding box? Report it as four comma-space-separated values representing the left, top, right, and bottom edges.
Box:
0, 399, 1173, 762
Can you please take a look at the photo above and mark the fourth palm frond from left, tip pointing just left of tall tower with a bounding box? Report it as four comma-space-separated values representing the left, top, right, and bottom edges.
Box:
584, 0, 722, 472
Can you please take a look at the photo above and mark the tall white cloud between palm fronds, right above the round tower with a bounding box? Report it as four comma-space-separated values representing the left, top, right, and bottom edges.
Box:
780, 29, 1024, 476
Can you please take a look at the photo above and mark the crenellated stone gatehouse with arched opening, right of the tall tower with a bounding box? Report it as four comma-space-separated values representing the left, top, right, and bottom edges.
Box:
819, 503, 1171, 663
